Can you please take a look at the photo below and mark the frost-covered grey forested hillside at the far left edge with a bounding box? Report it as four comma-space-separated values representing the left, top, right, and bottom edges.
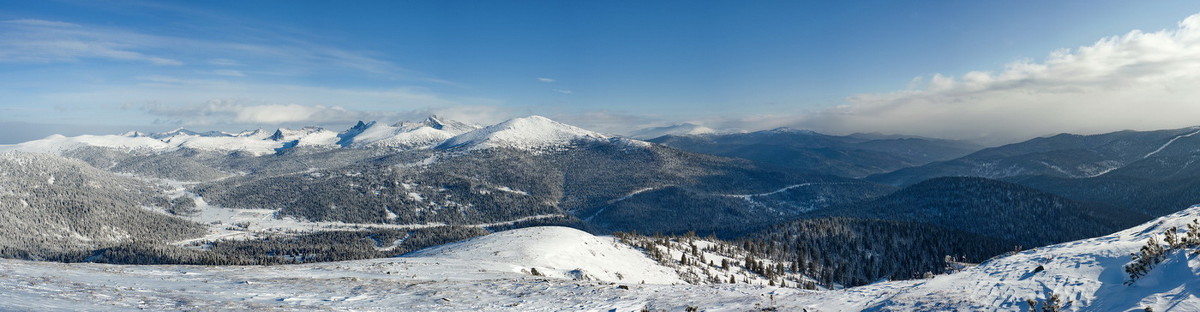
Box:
0, 152, 205, 259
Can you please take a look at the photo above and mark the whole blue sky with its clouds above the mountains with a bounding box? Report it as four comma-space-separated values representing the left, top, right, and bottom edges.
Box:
0, 0, 1200, 144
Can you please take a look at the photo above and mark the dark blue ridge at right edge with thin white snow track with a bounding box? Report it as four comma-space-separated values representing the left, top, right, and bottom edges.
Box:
866, 127, 1200, 216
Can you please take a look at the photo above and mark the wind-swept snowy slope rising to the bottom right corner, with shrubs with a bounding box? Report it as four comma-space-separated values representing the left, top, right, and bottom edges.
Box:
787, 206, 1200, 311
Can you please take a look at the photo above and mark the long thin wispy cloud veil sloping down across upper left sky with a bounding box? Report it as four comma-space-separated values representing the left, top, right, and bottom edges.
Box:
0, 19, 449, 83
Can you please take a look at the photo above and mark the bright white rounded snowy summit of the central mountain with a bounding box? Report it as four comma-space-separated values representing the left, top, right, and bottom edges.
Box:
438, 115, 608, 150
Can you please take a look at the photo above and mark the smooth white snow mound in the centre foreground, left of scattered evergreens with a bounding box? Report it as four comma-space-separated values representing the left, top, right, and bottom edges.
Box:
404, 227, 684, 284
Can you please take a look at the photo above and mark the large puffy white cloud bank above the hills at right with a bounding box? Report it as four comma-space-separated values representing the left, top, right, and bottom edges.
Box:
790, 14, 1200, 140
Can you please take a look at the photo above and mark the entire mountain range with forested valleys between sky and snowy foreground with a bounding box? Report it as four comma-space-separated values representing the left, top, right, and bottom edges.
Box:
0, 116, 1200, 307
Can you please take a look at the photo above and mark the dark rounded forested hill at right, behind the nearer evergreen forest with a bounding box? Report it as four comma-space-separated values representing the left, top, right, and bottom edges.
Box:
810, 178, 1151, 246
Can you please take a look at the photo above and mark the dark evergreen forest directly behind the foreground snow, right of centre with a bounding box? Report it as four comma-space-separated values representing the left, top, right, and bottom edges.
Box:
743, 217, 1014, 288
